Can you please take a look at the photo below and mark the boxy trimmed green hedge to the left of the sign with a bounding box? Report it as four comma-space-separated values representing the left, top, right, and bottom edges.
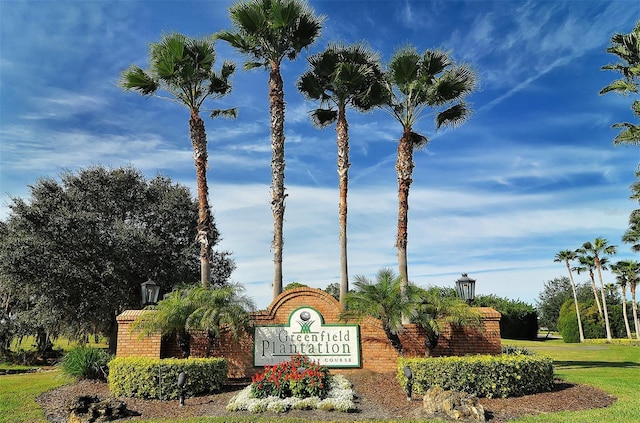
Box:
109, 357, 227, 400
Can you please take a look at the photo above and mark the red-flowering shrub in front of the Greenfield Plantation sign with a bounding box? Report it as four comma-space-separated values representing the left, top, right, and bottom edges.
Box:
251, 355, 329, 398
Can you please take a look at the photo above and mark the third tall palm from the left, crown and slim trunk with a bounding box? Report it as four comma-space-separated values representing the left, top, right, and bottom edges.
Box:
298, 44, 386, 306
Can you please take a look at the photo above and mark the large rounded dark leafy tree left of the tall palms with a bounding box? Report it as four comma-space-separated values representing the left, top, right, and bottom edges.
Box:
0, 167, 234, 349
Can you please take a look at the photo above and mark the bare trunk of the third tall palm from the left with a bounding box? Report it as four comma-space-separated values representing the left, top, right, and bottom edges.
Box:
336, 106, 351, 307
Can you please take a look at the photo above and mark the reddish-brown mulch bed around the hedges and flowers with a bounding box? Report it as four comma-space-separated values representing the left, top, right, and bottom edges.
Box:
37, 370, 616, 423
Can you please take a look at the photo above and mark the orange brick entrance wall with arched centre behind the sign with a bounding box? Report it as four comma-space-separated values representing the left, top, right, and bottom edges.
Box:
118, 287, 502, 378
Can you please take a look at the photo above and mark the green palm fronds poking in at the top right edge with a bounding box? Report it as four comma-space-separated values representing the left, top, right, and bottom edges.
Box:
600, 21, 640, 145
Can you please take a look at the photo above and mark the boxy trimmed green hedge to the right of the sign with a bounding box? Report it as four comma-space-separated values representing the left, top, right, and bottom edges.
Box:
397, 354, 553, 398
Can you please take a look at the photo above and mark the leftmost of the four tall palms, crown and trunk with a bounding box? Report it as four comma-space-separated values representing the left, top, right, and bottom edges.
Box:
120, 33, 236, 287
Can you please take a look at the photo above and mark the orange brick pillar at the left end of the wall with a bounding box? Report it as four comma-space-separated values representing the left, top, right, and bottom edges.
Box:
116, 310, 162, 358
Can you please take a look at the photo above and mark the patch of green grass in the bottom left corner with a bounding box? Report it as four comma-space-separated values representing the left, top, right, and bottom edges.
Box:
0, 371, 66, 423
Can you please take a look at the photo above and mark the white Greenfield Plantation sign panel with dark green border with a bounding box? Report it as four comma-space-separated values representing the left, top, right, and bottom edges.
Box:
253, 306, 360, 367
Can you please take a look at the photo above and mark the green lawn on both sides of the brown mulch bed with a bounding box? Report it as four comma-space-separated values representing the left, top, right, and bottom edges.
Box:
0, 339, 640, 423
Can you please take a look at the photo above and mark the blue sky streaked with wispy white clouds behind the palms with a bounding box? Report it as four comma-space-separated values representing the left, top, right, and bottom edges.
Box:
0, 0, 640, 307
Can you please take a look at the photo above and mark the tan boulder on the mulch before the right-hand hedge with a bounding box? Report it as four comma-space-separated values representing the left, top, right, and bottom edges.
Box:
423, 387, 485, 422
